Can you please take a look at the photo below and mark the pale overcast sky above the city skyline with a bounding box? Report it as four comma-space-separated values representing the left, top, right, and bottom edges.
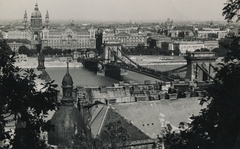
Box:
0, 0, 227, 22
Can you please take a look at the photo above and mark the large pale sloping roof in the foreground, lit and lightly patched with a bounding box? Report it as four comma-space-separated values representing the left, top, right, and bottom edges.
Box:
112, 98, 203, 138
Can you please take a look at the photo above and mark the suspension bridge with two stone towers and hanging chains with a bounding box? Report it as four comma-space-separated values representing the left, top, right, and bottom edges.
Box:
84, 41, 217, 82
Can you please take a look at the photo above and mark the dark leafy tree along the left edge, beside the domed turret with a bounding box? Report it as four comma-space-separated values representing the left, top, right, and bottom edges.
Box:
0, 40, 57, 149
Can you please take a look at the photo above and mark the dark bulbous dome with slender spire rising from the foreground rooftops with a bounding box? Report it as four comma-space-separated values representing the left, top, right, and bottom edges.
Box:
48, 61, 87, 145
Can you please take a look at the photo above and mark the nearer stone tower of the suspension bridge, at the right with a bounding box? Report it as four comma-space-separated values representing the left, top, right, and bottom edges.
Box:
184, 52, 217, 81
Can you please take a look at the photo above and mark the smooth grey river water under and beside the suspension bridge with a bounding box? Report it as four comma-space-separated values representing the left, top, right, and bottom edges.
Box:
46, 65, 184, 89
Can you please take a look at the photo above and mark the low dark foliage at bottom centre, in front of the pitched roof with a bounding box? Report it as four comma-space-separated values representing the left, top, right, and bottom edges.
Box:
58, 120, 129, 149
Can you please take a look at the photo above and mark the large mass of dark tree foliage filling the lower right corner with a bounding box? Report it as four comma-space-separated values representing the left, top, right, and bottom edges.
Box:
160, 37, 240, 149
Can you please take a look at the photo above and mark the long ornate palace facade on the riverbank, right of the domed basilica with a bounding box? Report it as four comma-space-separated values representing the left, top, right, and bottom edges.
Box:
42, 22, 96, 50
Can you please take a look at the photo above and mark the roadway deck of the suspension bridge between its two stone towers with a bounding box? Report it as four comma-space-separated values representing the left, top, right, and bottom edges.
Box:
105, 63, 180, 82
